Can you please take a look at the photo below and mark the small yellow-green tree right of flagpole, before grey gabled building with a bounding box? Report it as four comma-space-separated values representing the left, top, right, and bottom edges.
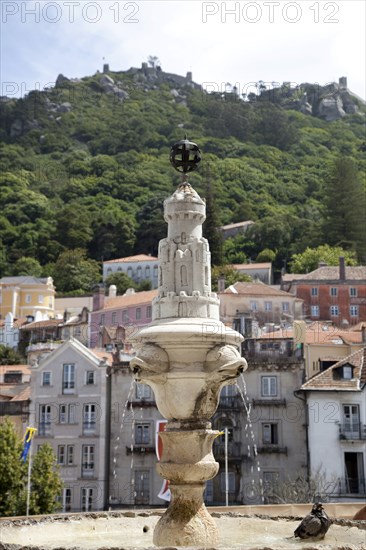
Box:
29, 443, 62, 514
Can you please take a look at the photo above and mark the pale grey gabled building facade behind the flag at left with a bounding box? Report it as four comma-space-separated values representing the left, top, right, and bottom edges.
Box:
31, 340, 112, 512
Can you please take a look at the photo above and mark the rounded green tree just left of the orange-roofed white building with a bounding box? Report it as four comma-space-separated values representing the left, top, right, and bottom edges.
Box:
52, 248, 101, 292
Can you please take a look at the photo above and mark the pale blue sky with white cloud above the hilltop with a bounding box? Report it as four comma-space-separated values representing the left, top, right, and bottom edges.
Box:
0, 0, 366, 99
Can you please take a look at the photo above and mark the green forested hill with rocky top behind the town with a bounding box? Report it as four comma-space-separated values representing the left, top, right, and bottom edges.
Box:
0, 64, 366, 288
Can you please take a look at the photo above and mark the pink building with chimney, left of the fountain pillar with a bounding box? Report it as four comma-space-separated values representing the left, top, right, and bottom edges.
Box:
89, 285, 158, 348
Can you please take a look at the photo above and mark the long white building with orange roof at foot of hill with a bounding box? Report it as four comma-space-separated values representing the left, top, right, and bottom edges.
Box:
103, 254, 159, 288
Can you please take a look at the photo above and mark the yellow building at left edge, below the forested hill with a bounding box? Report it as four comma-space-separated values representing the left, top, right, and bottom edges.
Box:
0, 276, 55, 321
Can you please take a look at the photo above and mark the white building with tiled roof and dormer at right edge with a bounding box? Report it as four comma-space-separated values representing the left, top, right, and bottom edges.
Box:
302, 347, 366, 501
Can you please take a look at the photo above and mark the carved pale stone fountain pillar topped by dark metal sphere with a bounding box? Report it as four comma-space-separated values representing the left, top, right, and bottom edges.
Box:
131, 139, 246, 546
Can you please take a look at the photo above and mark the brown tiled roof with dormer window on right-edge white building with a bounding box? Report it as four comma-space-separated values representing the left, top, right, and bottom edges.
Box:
301, 346, 366, 391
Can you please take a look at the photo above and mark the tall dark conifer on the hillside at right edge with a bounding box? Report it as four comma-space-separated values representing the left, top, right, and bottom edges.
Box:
324, 157, 366, 262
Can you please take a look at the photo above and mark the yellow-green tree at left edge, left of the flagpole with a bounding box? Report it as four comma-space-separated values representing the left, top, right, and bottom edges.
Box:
0, 417, 27, 516
